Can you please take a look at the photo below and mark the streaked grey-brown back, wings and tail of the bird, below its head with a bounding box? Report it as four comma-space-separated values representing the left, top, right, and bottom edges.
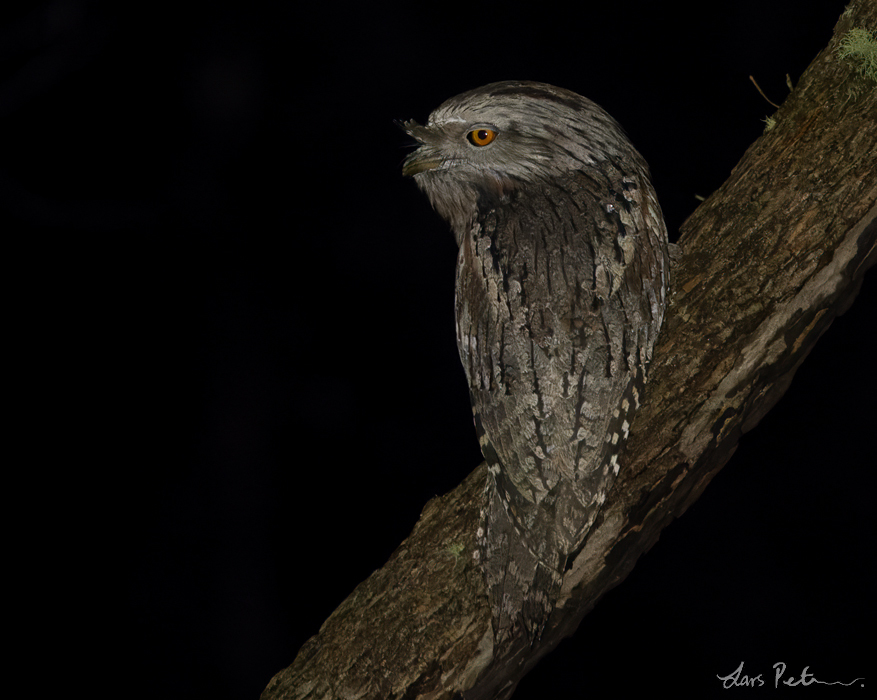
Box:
456, 162, 667, 632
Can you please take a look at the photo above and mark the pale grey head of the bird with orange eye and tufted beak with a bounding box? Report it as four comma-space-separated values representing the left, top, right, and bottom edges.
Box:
399, 81, 633, 240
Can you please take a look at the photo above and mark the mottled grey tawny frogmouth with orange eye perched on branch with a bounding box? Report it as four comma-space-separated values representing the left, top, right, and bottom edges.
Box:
398, 80, 670, 643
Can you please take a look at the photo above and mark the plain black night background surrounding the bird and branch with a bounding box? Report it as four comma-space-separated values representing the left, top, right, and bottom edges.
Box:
0, 0, 877, 700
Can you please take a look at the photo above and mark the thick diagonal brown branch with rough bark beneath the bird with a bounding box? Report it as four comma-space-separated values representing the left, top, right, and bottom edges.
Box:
262, 1, 877, 700
